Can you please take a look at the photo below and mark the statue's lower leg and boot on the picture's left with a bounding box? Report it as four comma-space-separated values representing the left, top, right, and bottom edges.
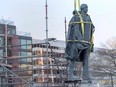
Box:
68, 61, 76, 80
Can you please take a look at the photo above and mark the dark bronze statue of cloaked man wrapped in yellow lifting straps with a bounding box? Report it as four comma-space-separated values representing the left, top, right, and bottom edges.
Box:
65, 4, 95, 80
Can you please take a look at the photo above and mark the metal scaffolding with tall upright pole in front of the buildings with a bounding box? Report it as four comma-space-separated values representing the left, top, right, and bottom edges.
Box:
0, 0, 86, 87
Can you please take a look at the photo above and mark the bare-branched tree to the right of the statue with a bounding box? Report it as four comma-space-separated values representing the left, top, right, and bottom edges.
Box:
90, 37, 116, 87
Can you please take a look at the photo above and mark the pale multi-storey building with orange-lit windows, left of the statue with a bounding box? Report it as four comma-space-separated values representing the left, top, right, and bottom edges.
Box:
32, 38, 66, 87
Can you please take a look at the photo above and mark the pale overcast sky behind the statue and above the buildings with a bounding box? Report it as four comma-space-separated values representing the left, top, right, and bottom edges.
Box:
0, 0, 116, 47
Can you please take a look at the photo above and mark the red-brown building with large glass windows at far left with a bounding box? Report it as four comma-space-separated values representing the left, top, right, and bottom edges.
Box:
0, 23, 32, 87
